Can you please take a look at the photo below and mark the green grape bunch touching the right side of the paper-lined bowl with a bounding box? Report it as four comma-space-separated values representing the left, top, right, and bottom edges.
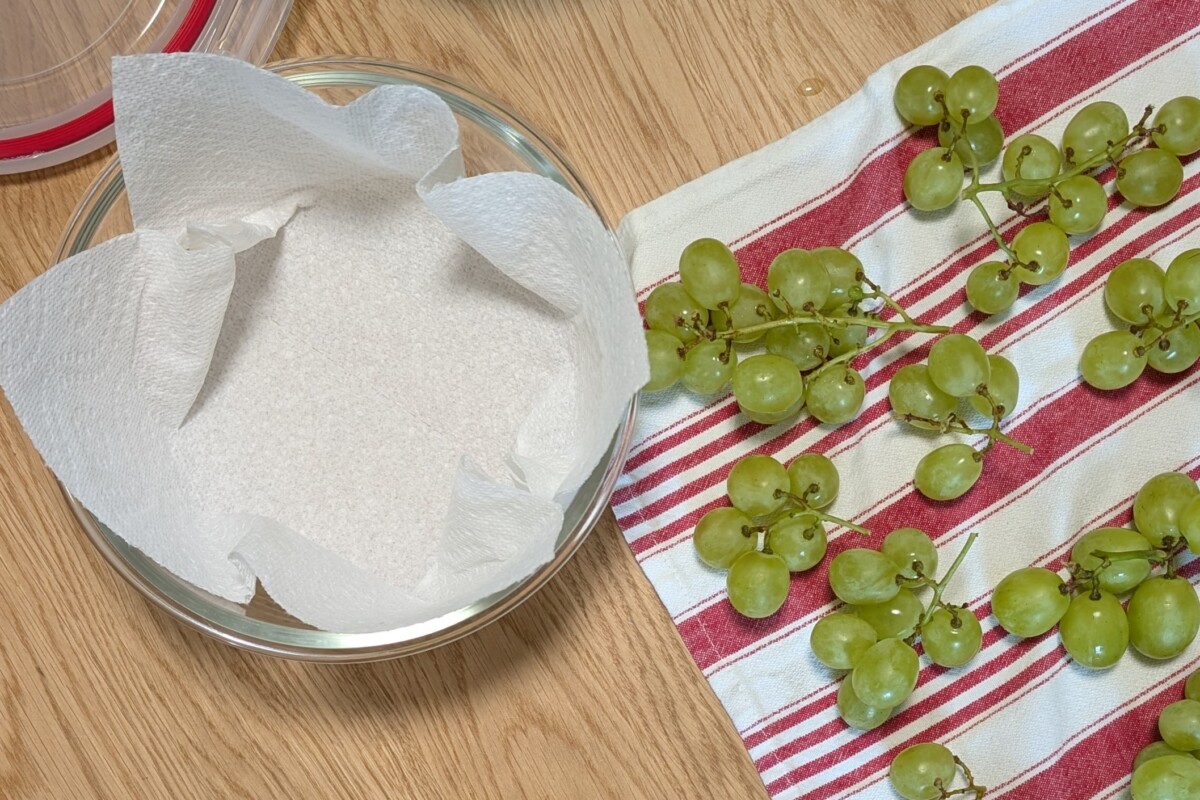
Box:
644, 239, 947, 425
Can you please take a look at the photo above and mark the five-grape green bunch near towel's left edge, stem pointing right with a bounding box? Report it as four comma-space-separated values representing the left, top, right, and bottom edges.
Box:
691, 453, 870, 619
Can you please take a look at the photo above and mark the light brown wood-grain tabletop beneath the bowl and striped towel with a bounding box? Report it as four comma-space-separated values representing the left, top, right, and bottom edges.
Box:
0, 0, 986, 800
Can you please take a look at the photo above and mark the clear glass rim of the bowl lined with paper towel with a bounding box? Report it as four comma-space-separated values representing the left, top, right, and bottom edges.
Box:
53, 55, 638, 663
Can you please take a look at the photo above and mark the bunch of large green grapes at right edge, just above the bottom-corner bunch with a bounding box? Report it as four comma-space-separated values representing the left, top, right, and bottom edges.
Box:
991, 473, 1200, 669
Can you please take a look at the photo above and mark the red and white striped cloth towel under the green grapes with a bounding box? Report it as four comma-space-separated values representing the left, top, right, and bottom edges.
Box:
613, 0, 1200, 800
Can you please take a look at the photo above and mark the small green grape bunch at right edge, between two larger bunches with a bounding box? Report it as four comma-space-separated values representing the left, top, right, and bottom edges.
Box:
1079, 248, 1200, 390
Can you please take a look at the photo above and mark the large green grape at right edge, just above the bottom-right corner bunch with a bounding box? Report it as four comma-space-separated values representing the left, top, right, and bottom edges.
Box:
1128, 575, 1200, 662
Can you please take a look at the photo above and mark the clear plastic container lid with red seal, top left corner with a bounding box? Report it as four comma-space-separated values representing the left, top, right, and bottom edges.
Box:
0, 0, 292, 175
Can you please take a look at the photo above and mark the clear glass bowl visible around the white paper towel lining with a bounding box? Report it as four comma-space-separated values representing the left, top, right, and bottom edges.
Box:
55, 58, 636, 662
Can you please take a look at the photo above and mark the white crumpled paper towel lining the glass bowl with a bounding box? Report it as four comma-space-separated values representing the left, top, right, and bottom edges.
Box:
0, 54, 647, 632
